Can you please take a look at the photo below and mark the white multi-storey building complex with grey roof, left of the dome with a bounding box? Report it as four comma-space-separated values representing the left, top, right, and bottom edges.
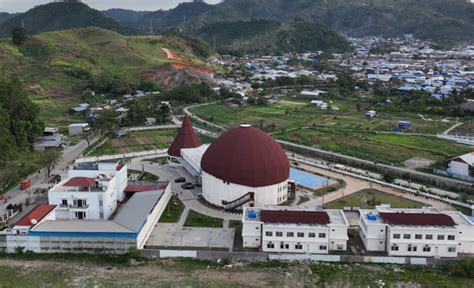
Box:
0, 161, 171, 254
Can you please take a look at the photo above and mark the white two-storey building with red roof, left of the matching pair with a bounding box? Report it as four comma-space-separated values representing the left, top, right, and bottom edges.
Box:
242, 206, 349, 254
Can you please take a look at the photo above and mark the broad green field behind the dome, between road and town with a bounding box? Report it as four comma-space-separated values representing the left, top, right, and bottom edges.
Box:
193, 100, 471, 164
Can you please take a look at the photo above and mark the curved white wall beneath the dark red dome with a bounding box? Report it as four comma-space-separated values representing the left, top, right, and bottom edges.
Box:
202, 171, 288, 207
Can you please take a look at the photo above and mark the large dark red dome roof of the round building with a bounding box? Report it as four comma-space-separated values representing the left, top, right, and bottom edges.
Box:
201, 125, 290, 187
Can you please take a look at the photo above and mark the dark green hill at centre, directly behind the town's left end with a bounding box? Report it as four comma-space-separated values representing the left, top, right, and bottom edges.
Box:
197, 19, 351, 53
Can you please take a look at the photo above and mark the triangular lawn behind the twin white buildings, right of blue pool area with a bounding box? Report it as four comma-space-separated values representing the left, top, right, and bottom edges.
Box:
324, 190, 423, 209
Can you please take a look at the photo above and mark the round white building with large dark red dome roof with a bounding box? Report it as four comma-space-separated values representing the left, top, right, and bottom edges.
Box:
201, 125, 290, 209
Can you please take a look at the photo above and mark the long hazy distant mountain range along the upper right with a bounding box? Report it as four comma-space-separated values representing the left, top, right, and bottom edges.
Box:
125, 0, 474, 44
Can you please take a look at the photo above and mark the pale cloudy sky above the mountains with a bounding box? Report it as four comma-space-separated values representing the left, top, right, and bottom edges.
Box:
0, 0, 220, 12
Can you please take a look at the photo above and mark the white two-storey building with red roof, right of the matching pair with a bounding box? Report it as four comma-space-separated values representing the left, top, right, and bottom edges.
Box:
359, 205, 474, 258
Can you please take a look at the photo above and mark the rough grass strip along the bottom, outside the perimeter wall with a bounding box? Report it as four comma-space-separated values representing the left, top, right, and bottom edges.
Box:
0, 254, 474, 288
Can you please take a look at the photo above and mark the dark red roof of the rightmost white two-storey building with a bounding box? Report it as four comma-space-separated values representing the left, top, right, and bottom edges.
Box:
380, 213, 456, 226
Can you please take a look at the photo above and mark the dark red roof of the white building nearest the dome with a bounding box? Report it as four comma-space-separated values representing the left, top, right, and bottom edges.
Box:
260, 210, 330, 225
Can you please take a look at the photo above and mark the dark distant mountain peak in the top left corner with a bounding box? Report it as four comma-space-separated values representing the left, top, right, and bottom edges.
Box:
0, 2, 135, 36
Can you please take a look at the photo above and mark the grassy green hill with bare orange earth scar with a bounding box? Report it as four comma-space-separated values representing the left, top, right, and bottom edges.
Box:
0, 28, 210, 105
